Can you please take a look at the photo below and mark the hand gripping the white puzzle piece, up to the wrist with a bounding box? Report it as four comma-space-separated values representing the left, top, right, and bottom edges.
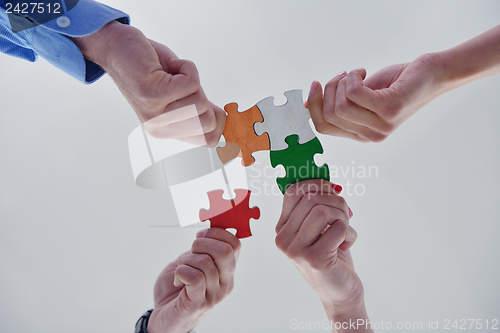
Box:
307, 54, 446, 142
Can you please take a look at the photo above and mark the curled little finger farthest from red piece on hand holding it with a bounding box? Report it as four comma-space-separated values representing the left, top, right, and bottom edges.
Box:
175, 265, 207, 304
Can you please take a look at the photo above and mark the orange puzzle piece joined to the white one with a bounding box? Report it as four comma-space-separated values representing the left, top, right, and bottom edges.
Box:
217, 103, 270, 166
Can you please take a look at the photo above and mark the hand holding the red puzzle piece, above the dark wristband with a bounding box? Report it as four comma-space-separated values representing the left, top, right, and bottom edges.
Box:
148, 228, 241, 333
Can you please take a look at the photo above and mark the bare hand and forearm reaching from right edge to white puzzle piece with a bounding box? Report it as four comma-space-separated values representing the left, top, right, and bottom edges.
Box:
307, 26, 500, 142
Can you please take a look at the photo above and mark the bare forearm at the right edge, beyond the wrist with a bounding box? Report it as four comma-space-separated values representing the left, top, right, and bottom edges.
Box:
434, 25, 500, 91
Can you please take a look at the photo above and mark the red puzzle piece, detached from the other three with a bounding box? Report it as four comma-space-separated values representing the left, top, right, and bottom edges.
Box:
200, 189, 260, 238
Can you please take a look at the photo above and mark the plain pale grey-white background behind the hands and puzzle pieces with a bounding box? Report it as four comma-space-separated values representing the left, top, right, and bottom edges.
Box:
0, 0, 500, 333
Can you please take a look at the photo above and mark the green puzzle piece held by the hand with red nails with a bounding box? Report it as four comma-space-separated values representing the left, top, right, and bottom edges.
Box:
271, 134, 330, 194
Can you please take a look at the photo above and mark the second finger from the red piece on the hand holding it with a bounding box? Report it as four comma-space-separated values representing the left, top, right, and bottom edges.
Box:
191, 237, 236, 295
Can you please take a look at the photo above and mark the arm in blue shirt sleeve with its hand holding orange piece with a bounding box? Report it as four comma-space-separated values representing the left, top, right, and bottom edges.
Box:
0, 0, 225, 146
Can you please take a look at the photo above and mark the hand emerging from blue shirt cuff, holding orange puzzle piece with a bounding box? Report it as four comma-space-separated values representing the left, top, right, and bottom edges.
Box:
72, 21, 226, 146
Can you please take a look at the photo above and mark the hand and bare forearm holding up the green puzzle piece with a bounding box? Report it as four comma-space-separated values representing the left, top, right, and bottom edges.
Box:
276, 180, 372, 332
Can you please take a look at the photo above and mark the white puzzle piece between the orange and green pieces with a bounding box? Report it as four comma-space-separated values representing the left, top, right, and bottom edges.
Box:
254, 90, 316, 151
